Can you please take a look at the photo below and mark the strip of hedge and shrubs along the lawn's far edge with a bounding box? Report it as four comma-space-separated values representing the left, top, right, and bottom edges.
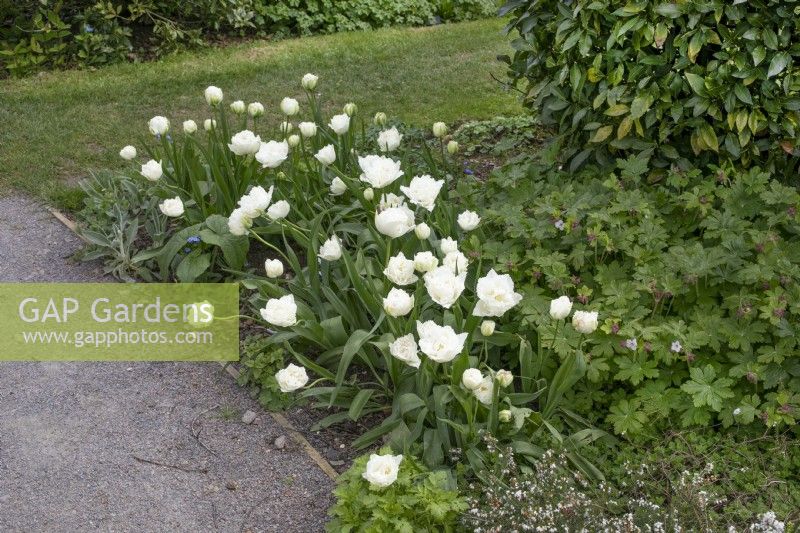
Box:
0, 0, 496, 76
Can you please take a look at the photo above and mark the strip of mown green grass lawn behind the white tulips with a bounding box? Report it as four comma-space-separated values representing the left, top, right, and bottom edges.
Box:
0, 20, 518, 201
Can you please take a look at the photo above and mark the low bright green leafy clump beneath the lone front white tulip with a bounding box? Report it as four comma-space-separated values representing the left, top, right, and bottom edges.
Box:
328, 448, 466, 533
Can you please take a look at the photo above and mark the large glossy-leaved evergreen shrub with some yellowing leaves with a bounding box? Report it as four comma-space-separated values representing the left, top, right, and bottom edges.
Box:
502, 0, 800, 170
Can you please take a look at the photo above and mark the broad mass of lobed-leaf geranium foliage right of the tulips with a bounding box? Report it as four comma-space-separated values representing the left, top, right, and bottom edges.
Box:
478, 157, 800, 436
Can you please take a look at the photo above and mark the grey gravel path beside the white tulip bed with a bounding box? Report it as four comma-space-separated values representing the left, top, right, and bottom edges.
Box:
0, 196, 333, 532
